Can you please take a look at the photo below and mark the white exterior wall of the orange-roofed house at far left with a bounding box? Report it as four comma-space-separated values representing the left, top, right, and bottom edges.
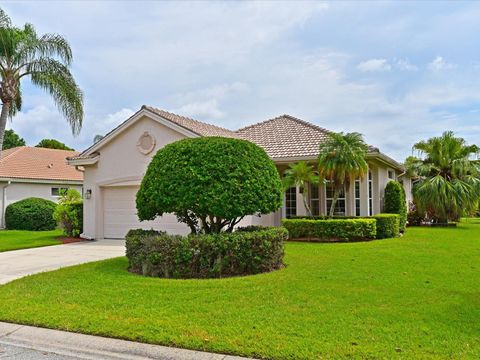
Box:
0, 182, 82, 228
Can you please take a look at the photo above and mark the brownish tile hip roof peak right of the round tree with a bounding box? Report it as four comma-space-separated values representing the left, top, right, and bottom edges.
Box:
237, 115, 329, 159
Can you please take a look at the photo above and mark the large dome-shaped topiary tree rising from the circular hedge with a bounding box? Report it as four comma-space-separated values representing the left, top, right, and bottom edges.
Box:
137, 137, 282, 234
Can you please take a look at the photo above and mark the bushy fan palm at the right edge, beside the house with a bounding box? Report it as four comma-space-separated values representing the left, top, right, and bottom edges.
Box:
405, 131, 480, 223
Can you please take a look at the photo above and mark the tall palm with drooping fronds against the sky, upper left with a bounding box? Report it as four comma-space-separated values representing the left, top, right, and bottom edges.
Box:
0, 16, 83, 155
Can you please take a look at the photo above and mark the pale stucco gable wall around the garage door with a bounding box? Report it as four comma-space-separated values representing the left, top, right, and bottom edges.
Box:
84, 117, 185, 239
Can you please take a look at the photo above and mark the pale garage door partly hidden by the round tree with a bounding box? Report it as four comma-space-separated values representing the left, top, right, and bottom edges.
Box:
103, 186, 189, 239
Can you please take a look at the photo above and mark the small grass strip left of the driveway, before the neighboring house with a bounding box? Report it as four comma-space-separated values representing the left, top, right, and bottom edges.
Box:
0, 230, 62, 252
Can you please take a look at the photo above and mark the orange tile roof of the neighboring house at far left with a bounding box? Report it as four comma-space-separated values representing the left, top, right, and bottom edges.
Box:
0, 146, 83, 181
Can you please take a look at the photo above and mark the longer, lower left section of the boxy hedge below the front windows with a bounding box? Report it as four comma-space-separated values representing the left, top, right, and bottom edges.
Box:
282, 218, 377, 241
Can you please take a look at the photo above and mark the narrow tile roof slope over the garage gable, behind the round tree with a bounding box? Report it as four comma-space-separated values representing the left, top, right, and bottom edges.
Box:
142, 105, 238, 137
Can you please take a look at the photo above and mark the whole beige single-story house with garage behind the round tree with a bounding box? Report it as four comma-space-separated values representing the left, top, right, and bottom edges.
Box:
68, 106, 411, 239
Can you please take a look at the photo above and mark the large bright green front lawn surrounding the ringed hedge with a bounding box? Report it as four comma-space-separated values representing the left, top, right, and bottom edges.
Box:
0, 221, 480, 359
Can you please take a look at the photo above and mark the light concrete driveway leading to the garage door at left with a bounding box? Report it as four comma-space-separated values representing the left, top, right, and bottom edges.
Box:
0, 240, 125, 284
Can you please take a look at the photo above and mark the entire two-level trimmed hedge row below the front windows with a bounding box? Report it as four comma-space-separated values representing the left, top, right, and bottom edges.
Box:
282, 214, 400, 241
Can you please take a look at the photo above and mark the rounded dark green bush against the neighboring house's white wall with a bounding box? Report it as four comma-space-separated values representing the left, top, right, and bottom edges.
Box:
5, 198, 57, 231
